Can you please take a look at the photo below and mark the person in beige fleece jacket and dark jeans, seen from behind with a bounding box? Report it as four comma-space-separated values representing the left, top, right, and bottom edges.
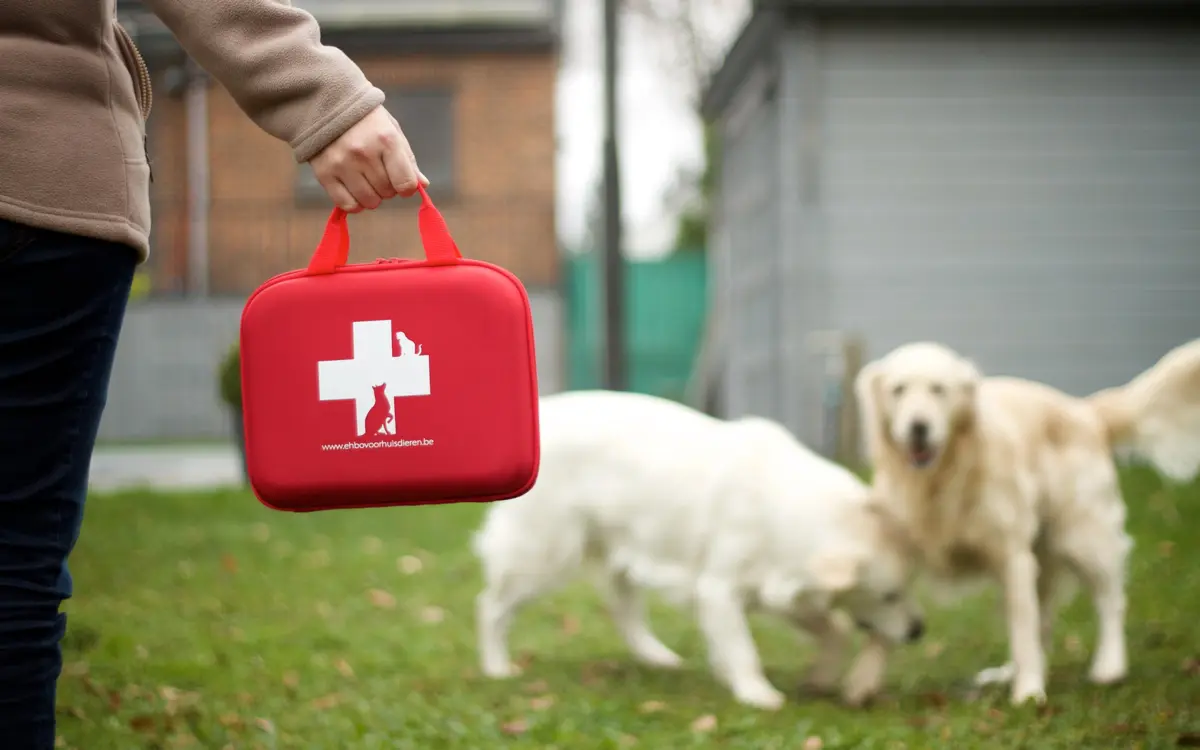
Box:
0, 0, 428, 750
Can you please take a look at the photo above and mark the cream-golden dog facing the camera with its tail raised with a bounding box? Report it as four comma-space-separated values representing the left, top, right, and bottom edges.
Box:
856, 340, 1200, 703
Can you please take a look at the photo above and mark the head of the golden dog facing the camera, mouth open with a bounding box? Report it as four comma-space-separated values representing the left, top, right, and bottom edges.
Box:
854, 342, 980, 469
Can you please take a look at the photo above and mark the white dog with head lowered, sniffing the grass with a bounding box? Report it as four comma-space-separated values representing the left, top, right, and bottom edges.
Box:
474, 391, 924, 709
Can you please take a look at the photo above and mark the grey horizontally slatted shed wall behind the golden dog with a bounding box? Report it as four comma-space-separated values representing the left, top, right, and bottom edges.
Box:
821, 16, 1200, 394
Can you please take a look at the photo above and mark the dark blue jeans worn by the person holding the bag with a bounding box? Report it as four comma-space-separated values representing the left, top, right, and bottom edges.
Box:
0, 220, 137, 750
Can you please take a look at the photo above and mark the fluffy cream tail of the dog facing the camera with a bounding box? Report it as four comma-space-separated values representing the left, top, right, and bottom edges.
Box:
1087, 338, 1200, 481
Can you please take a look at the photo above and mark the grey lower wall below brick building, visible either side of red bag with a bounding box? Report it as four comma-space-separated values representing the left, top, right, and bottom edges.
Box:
100, 290, 564, 442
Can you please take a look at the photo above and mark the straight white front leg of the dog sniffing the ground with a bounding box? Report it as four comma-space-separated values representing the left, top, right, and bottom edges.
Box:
696, 578, 785, 710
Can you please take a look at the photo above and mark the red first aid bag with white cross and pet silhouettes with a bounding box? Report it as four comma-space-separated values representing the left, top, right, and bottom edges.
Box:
241, 190, 540, 511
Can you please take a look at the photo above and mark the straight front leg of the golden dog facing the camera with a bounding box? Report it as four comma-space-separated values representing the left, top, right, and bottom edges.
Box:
1004, 548, 1046, 704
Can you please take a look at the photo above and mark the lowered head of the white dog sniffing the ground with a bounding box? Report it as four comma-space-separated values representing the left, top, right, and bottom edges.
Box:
812, 498, 925, 643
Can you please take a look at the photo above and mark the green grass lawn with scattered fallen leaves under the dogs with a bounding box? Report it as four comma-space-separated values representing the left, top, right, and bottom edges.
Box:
58, 473, 1200, 750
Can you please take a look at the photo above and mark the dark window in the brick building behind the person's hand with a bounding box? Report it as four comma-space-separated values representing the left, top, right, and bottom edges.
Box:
296, 86, 456, 202
